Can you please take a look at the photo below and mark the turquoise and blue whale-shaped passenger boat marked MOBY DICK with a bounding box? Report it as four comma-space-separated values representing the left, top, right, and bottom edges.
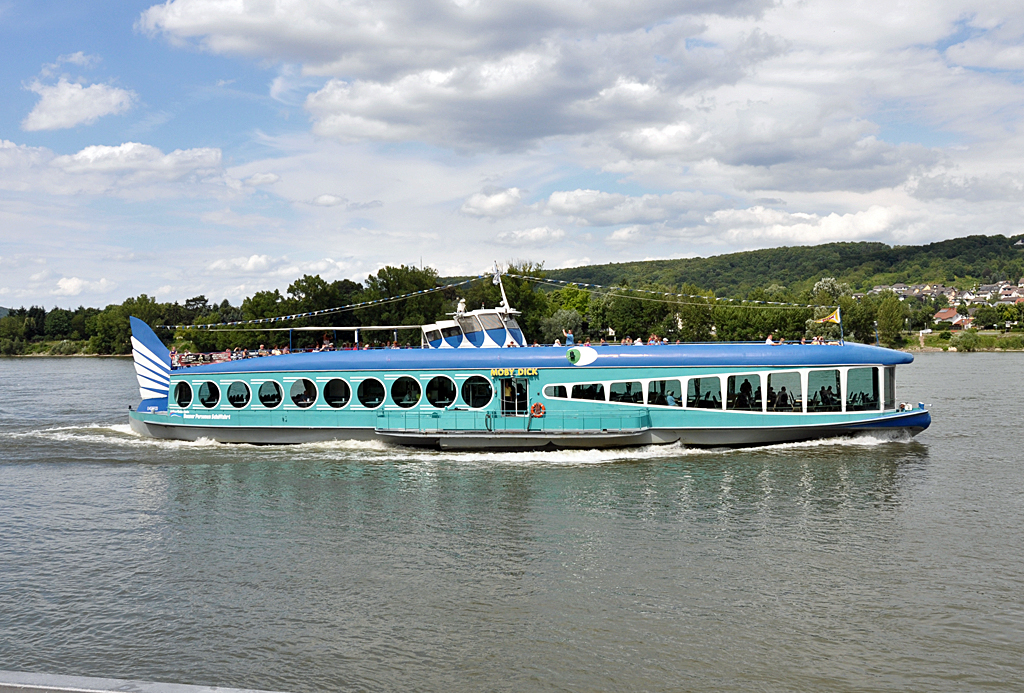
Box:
123, 284, 931, 449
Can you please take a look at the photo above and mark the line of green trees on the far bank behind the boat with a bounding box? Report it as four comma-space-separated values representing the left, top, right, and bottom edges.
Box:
0, 262, 958, 354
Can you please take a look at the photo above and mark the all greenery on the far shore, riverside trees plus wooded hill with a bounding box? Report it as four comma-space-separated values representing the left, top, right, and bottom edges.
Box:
0, 235, 1024, 356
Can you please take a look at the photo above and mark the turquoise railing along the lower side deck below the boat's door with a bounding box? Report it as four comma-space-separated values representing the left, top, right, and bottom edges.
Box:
376, 409, 651, 433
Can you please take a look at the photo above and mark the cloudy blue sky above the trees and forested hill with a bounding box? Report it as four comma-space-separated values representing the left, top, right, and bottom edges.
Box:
0, 0, 1024, 308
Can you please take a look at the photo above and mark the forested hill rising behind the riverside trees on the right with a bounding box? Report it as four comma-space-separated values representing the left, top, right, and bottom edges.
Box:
547, 235, 1024, 296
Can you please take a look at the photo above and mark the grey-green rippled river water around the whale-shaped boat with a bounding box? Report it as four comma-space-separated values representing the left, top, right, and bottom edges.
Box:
0, 353, 1024, 692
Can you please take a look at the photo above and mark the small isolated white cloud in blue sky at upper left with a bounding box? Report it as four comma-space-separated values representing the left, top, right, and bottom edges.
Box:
22, 77, 137, 132
